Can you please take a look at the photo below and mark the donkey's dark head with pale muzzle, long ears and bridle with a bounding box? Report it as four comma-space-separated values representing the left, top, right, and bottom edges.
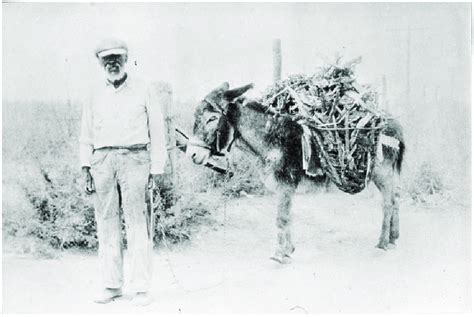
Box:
186, 83, 253, 164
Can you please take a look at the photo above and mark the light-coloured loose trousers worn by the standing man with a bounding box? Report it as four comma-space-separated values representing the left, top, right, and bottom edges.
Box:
91, 148, 152, 292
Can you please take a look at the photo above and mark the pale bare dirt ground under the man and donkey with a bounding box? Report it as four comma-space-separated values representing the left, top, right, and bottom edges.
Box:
3, 191, 472, 313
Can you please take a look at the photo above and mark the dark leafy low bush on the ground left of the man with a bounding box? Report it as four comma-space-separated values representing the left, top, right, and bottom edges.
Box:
3, 158, 97, 249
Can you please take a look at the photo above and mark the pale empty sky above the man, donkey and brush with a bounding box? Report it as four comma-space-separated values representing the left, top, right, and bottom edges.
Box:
2, 3, 470, 106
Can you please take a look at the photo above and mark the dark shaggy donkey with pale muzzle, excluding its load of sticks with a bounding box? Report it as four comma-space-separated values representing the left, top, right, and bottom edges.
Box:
187, 83, 405, 264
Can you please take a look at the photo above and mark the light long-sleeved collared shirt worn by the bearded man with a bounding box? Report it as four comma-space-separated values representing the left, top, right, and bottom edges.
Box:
79, 77, 172, 174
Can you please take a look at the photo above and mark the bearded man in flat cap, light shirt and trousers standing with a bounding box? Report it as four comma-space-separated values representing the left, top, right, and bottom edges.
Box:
80, 39, 171, 305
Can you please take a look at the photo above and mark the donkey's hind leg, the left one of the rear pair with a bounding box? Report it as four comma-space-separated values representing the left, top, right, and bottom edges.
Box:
373, 161, 398, 250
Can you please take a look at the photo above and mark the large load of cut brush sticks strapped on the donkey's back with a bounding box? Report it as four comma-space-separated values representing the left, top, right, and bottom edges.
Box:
261, 58, 388, 194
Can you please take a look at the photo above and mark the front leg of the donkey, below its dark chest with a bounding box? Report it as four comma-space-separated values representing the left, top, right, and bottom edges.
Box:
271, 186, 295, 263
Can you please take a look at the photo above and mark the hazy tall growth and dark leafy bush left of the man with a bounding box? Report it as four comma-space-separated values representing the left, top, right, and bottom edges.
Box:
3, 99, 97, 252
